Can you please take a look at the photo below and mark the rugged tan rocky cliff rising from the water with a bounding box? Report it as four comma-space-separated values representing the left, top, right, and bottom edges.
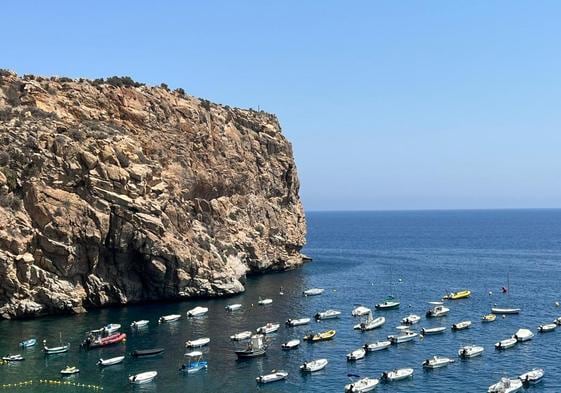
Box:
0, 71, 306, 318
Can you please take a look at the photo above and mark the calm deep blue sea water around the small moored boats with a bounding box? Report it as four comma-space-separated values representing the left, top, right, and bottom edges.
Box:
0, 210, 561, 392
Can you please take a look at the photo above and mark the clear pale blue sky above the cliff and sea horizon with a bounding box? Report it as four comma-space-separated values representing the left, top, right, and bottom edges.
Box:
4, 0, 561, 210
